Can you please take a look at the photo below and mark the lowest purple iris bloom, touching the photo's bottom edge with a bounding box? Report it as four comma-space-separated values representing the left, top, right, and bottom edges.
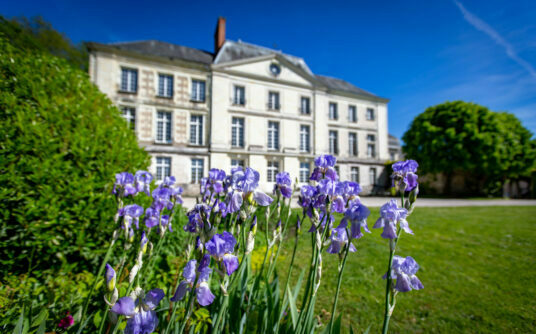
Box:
111, 289, 164, 334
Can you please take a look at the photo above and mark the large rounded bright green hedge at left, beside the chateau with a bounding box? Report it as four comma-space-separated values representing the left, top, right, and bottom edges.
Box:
0, 36, 149, 277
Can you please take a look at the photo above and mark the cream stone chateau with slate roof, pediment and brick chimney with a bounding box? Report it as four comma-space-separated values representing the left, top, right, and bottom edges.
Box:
88, 18, 393, 193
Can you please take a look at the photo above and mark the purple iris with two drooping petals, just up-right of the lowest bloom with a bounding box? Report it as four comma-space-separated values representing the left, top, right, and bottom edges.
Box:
171, 259, 215, 306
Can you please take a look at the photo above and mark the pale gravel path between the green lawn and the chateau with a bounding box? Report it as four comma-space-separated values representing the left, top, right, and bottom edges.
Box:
184, 196, 536, 209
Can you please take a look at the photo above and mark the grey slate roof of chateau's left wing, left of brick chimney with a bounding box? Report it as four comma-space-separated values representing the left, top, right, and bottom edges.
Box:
89, 40, 214, 65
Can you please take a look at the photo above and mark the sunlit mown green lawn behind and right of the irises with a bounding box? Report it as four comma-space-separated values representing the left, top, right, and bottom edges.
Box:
279, 207, 536, 333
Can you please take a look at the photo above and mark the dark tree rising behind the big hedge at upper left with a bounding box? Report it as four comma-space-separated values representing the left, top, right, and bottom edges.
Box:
0, 15, 88, 72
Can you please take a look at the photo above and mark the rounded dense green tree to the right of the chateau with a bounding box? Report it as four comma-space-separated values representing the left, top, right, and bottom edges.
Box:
402, 101, 536, 194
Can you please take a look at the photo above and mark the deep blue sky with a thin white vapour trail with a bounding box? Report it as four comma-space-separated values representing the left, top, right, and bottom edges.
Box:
0, 0, 536, 137
